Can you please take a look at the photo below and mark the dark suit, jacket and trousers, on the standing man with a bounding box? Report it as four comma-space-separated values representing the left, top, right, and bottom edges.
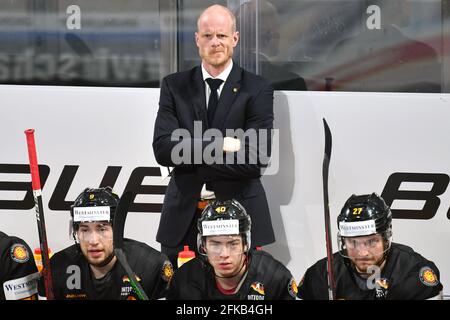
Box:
153, 64, 275, 247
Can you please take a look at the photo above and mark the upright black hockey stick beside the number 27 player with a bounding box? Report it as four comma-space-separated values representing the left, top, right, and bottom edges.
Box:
322, 118, 336, 300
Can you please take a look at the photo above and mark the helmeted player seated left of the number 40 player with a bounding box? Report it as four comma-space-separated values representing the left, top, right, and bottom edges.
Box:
39, 187, 173, 300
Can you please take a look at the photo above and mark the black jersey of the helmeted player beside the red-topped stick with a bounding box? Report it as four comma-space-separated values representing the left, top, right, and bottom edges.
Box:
39, 239, 173, 300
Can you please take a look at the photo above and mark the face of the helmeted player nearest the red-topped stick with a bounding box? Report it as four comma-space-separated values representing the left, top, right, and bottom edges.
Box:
77, 222, 114, 266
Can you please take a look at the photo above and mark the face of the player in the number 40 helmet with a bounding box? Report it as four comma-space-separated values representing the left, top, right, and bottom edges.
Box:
205, 235, 246, 277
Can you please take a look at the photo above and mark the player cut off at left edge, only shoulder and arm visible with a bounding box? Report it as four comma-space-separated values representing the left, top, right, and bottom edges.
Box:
0, 232, 39, 300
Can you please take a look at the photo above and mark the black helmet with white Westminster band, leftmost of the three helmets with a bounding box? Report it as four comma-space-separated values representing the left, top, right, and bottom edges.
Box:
70, 187, 119, 231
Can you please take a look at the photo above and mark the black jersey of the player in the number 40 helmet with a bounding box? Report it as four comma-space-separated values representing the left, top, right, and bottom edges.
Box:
167, 250, 297, 300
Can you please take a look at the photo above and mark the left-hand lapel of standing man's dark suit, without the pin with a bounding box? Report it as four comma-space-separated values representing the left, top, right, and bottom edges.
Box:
188, 67, 208, 128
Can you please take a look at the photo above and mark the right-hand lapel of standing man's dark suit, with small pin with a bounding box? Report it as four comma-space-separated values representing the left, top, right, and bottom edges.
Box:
211, 63, 242, 129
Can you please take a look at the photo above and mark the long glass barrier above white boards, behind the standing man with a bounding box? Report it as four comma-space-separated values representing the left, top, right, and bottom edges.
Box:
0, 0, 450, 92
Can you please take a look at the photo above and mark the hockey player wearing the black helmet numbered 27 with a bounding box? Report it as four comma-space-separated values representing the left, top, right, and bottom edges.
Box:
298, 193, 442, 300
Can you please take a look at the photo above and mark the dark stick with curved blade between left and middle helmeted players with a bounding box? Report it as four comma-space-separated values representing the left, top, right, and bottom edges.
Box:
113, 192, 149, 300
